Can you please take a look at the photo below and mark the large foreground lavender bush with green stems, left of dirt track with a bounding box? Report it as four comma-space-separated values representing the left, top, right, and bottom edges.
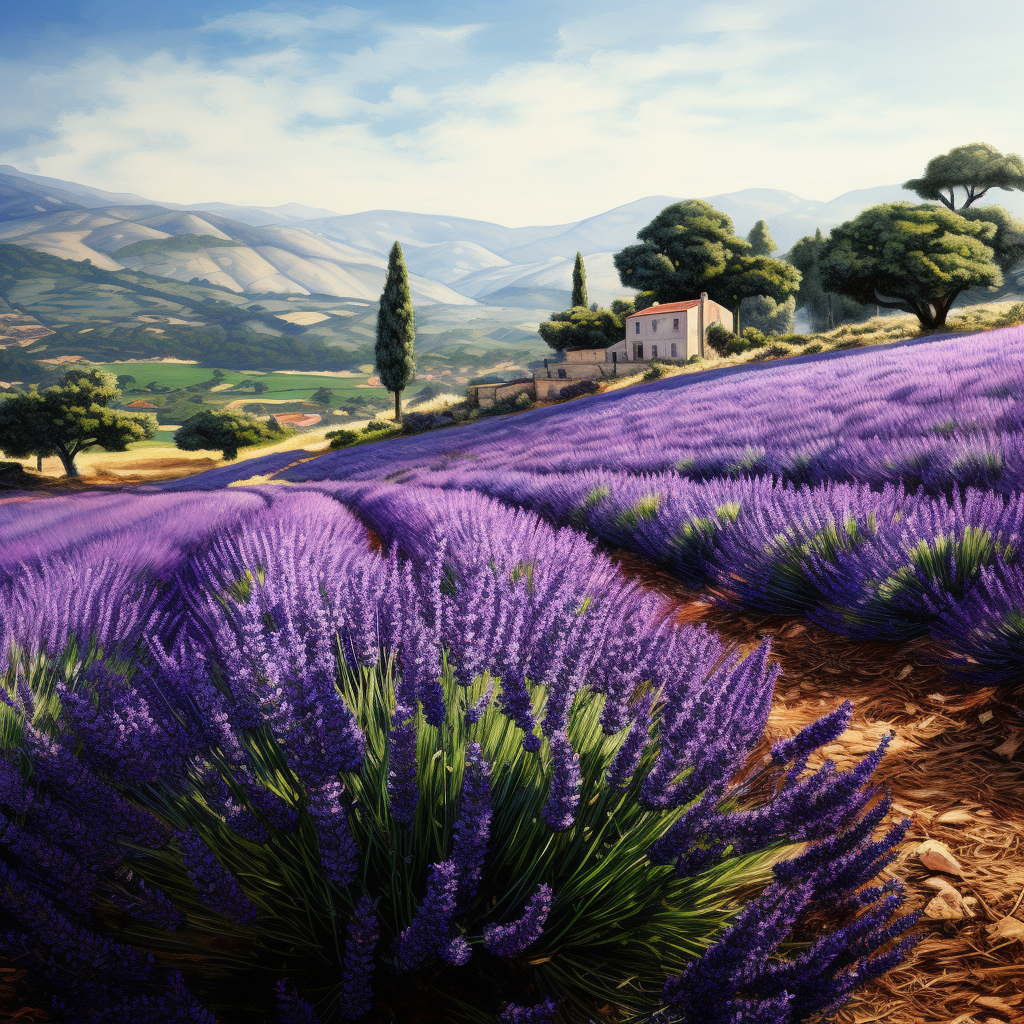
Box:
0, 484, 912, 1024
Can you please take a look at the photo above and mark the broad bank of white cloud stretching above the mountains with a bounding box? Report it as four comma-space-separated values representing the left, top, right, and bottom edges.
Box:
3, 0, 1020, 223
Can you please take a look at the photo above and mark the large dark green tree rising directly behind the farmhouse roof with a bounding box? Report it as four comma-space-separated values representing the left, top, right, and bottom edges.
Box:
614, 199, 800, 331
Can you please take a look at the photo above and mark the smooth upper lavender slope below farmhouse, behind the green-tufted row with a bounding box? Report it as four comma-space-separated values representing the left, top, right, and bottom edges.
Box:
280, 327, 1024, 494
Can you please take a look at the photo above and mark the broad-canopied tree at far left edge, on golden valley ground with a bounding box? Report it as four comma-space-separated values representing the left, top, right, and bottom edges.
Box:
0, 370, 156, 476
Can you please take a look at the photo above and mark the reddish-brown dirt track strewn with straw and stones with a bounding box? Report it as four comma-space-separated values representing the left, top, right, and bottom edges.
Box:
616, 553, 1024, 1024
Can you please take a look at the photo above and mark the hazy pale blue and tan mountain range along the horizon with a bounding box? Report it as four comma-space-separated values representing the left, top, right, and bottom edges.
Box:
0, 166, 1024, 311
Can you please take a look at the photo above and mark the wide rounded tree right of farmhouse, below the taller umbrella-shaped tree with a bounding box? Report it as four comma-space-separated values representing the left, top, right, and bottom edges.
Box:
821, 203, 1024, 330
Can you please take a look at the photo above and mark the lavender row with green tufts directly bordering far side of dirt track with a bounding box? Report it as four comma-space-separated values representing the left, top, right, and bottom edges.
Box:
380, 469, 1024, 684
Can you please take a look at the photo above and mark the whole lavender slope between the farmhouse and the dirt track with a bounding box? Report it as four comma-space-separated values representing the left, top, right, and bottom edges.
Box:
281, 327, 1024, 685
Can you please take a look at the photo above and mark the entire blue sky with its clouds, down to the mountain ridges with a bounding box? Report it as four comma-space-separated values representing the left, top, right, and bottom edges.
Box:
0, 0, 1024, 225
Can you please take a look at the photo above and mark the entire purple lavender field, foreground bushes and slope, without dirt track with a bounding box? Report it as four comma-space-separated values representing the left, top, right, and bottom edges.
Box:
0, 328, 1024, 1024
